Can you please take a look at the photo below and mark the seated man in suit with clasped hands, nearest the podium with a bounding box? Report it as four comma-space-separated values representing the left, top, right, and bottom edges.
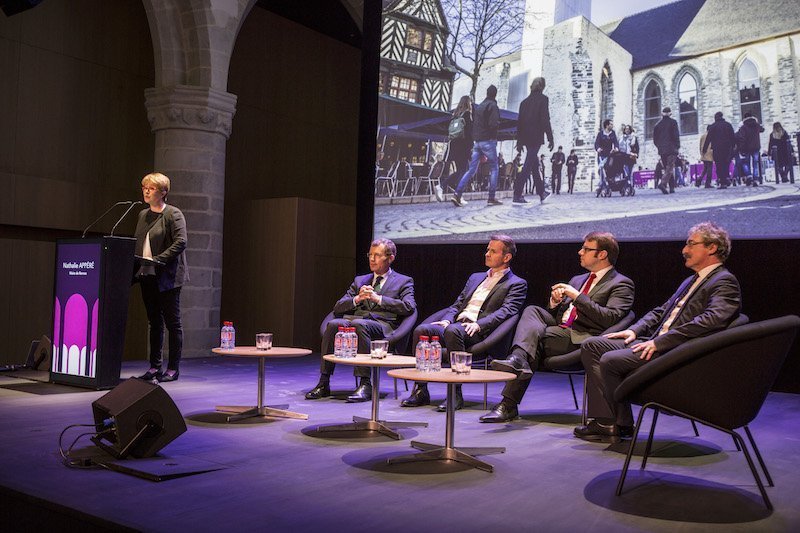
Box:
306, 239, 417, 402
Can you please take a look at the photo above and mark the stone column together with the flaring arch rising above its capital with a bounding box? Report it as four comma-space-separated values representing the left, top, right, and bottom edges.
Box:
142, 0, 256, 357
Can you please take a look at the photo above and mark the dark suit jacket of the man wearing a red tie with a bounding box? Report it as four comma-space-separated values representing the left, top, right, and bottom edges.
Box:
550, 268, 634, 344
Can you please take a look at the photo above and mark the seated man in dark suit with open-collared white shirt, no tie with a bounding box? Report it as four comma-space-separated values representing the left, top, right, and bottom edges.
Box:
400, 235, 528, 411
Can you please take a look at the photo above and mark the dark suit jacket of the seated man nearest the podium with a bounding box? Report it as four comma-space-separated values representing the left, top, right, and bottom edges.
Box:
333, 270, 417, 334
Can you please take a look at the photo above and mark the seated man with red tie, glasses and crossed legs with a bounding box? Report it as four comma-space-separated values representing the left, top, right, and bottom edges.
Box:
481, 232, 634, 422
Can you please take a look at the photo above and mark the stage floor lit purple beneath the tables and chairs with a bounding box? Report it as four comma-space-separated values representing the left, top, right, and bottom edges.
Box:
0, 356, 800, 532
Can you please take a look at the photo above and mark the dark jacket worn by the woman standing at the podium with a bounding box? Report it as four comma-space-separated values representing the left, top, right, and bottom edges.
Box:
133, 204, 189, 292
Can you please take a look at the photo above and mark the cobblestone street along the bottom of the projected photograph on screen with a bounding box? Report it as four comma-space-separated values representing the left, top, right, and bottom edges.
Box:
375, 183, 800, 242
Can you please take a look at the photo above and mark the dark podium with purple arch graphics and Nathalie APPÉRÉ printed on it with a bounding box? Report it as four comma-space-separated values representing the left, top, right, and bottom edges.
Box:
50, 237, 136, 390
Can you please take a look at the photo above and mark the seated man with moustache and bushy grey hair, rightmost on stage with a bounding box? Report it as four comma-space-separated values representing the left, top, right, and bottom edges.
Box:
575, 222, 742, 442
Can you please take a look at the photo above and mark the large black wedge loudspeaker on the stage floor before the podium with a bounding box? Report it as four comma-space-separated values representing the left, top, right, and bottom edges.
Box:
92, 378, 186, 459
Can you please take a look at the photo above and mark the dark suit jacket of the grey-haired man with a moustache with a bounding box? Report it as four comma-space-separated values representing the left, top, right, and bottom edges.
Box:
630, 265, 742, 353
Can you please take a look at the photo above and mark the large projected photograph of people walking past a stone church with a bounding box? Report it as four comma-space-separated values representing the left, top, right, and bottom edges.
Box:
374, 0, 800, 243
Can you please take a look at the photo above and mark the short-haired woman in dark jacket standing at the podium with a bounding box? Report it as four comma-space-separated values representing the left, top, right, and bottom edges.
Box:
134, 172, 189, 382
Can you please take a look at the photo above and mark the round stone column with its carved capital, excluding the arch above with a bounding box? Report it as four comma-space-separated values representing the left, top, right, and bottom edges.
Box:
145, 85, 236, 357
